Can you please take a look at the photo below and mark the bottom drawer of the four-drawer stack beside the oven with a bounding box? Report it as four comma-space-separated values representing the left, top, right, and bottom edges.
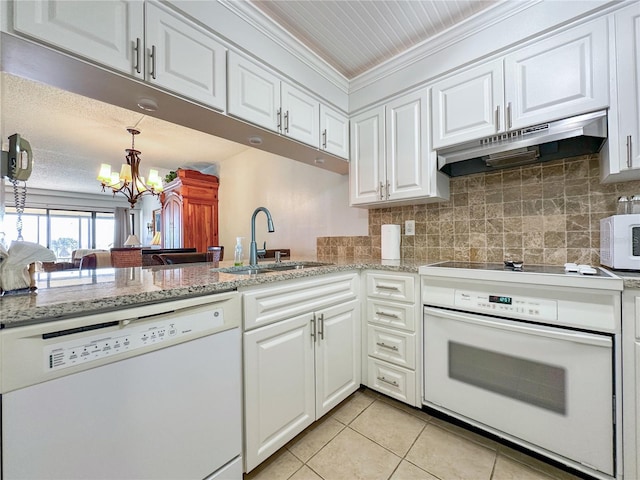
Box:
367, 357, 416, 406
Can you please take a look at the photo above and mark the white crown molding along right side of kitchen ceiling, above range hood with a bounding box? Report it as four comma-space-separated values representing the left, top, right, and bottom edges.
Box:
349, 0, 544, 93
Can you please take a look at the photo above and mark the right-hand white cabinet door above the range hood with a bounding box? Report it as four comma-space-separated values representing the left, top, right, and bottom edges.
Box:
505, 18, 609, 129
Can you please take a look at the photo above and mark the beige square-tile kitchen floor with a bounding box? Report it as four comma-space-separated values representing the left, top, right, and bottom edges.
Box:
245, 389, 577, 480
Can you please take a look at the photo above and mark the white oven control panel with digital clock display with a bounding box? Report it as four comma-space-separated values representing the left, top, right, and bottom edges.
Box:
454, 290, 558, 321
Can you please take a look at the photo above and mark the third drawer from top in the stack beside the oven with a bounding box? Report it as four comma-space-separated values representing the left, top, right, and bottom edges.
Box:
367, 325, 416, 369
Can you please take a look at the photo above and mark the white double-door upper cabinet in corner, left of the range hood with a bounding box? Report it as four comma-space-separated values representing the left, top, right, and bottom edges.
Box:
349, 89, 448, 206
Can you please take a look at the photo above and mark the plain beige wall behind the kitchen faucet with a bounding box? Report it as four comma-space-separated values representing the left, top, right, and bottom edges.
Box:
218, 149, 368, 259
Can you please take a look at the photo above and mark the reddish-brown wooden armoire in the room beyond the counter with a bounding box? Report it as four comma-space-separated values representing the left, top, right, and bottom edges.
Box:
160, 170, 219, 252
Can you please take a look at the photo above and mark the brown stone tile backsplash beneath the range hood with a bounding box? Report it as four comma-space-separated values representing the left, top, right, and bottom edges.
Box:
317, 155, 640, 265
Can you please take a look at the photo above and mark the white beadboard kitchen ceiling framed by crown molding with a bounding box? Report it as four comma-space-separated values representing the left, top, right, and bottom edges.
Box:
250, 0, 498, 79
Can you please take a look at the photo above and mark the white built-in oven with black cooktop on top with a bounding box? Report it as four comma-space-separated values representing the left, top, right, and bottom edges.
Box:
420, 262, 623, 479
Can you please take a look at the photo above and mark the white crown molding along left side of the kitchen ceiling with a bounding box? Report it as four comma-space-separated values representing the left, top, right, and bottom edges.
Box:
218, 0, 349, 94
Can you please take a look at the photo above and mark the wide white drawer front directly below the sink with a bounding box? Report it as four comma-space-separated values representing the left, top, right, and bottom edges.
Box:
242, 272, 359, 330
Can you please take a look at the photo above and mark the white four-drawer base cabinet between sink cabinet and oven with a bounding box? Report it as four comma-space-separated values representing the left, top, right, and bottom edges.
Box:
362, 271, 422, 406
